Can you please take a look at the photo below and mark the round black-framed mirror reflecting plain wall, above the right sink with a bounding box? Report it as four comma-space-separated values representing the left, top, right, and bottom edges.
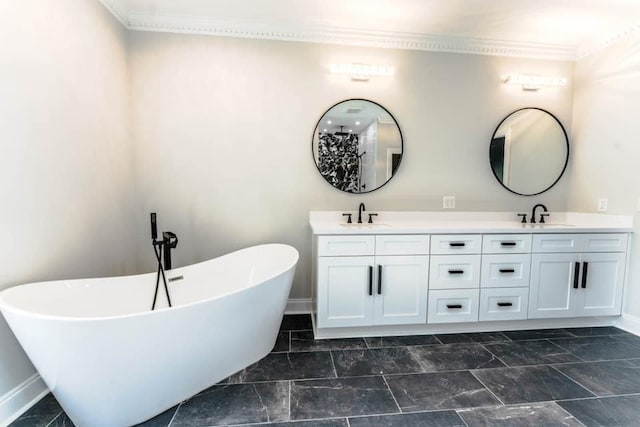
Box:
489, 108, 569, 196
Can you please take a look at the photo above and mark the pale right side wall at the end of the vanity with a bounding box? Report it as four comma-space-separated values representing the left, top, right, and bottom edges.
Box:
569, 35, 640, 321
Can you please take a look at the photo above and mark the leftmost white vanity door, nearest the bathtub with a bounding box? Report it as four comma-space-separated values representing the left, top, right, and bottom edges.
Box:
317, 256, 375, 328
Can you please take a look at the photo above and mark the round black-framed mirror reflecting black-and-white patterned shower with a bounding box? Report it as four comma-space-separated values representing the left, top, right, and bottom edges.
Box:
312, 99, 402, 194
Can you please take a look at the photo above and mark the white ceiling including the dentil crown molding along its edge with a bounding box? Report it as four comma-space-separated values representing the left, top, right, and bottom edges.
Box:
100, 0, 640, 59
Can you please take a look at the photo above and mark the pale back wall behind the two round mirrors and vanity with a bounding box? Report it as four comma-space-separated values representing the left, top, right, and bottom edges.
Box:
130, 32, 574, 298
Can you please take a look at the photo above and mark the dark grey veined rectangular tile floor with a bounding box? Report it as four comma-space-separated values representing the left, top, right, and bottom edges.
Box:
11, 315, 640, 427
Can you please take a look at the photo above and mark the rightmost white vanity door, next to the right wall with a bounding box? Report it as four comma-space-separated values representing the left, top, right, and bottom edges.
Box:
576, 253, 626, 316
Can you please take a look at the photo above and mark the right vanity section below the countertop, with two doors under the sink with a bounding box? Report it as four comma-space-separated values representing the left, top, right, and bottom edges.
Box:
529, 233, 628, 319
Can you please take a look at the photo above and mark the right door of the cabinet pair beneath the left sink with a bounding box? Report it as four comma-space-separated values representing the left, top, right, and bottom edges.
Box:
373, 256, 429, 325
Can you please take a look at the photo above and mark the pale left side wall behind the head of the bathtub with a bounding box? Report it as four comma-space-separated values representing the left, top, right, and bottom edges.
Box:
0, 0, 136, 402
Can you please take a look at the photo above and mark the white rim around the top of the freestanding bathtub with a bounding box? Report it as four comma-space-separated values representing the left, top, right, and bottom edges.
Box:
0, 243, 300, 323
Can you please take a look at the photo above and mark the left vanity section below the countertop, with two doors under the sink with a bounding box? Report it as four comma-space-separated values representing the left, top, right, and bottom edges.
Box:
316, 235, 429, 328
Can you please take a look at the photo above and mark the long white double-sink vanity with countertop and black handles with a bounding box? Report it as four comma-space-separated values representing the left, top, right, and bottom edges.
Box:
310, 211, 633, 338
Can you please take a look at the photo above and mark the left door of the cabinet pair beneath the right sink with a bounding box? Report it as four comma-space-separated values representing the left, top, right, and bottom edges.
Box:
529, 253, 580, 319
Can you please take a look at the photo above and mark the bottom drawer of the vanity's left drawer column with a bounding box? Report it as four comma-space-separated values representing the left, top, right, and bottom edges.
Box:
427, 289, 480, 323
